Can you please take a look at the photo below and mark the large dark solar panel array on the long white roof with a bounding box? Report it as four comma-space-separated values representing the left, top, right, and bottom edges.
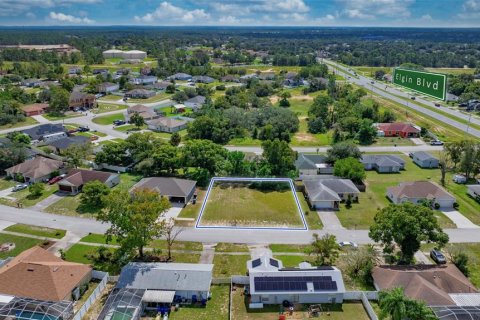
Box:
254, 276, 337, 292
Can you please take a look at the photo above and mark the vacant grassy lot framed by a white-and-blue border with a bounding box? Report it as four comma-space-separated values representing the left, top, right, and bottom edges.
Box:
201, 182, 303, 227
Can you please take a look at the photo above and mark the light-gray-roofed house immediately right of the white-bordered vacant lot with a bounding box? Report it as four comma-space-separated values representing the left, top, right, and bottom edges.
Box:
303, 178, 360, 210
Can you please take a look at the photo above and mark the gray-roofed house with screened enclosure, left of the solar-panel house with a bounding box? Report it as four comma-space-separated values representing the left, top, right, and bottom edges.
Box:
97, 262, 213, 320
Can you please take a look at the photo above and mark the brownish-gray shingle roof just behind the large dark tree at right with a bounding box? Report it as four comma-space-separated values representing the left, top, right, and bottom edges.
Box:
388, 181, 455, 200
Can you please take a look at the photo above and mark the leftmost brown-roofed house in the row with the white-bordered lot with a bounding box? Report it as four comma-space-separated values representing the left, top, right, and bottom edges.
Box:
5, 157, 65, 183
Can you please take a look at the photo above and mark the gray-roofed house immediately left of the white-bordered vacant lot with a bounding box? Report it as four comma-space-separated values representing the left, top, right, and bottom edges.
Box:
130, 177, 197, 205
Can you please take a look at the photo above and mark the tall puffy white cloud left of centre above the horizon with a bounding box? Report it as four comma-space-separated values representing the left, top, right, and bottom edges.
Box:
134, 1, 210, 24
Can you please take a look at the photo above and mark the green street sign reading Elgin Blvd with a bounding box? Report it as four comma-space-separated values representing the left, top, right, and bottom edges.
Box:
393, 68, 447, 100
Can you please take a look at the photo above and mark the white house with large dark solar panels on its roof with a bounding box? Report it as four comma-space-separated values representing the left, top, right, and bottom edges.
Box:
247, 255, 345, 308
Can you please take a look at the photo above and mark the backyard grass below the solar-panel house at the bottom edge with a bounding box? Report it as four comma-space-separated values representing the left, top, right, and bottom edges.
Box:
232, 287, 369, 320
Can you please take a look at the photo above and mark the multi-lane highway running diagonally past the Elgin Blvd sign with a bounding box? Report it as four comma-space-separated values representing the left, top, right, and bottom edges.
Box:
322, 60, 480, 138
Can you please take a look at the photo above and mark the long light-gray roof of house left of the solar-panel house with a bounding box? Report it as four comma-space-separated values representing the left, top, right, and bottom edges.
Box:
117, 262, 213, 291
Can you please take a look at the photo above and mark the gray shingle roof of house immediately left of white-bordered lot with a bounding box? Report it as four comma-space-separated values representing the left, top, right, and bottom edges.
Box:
131, 177, 197, 197
